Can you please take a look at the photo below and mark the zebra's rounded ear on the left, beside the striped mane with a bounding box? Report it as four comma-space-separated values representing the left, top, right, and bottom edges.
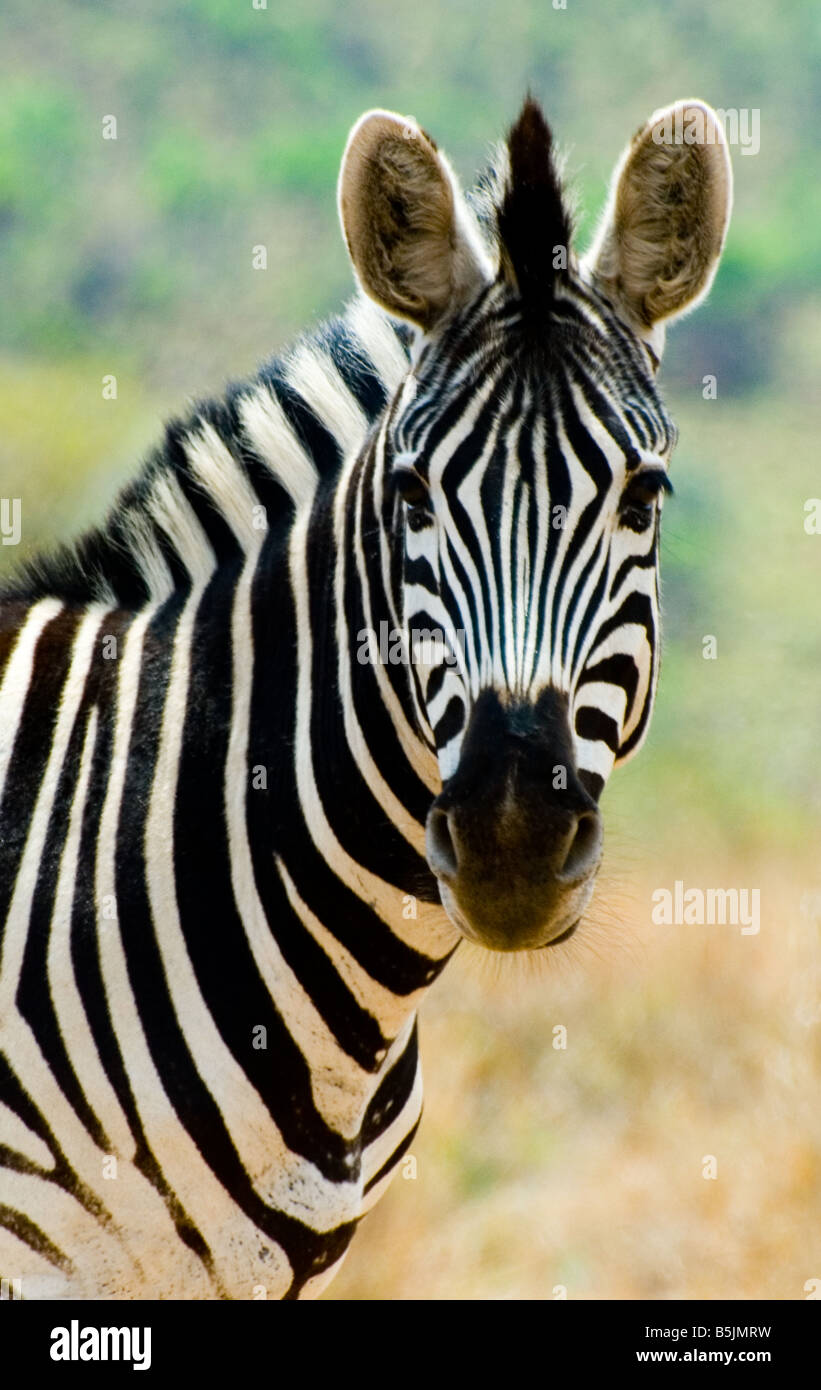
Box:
339, 111, 493, 331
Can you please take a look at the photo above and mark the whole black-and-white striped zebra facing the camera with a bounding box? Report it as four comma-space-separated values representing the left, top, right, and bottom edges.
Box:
0, 96, 732, 1300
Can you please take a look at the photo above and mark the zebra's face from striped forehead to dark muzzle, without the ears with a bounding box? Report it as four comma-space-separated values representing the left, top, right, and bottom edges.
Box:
386, 284, 674, 949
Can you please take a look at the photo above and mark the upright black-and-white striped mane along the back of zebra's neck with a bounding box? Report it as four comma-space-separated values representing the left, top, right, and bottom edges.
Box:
0, 299, 410, 609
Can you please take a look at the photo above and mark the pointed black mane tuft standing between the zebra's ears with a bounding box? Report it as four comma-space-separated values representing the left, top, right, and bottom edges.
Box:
497, 96, 572, 314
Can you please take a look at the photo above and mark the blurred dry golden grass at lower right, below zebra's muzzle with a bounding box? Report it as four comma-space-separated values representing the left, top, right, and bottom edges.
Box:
325, 856, 821, 1300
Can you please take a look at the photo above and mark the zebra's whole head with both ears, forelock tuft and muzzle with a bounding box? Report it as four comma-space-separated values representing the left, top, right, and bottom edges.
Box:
339, 100, 732, 951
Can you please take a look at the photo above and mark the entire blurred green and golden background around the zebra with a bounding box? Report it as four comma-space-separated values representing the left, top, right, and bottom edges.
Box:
0, 0, 821, 1300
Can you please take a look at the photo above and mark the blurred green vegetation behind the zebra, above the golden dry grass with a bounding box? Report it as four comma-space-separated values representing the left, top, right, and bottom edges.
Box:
0, 0, 821, 853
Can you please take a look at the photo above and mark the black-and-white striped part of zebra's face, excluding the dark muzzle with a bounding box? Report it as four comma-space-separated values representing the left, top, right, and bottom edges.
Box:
389, 285, 674, 798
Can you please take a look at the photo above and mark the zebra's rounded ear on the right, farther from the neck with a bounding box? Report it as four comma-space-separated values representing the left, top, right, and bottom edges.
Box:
582, 100, 732, 353
